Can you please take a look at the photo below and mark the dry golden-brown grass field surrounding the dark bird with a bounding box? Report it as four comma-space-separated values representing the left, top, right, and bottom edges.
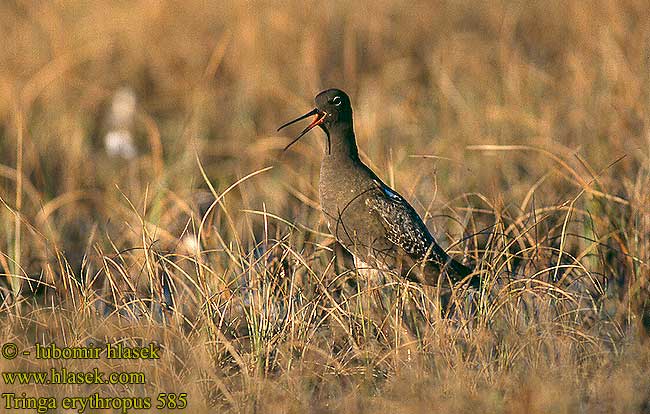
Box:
0, 0, 650, 413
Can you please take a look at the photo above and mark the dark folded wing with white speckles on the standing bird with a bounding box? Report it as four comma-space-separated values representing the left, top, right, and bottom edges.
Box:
366, 180, 471, 281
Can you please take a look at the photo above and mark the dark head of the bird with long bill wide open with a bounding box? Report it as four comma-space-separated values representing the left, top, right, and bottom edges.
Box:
278, 89, 352, 151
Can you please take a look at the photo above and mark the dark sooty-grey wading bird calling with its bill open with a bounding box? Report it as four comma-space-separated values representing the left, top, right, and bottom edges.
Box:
278, 89, 481, 289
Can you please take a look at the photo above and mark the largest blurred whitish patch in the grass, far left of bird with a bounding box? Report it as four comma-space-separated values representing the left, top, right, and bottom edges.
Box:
104, 86, 138, 159
